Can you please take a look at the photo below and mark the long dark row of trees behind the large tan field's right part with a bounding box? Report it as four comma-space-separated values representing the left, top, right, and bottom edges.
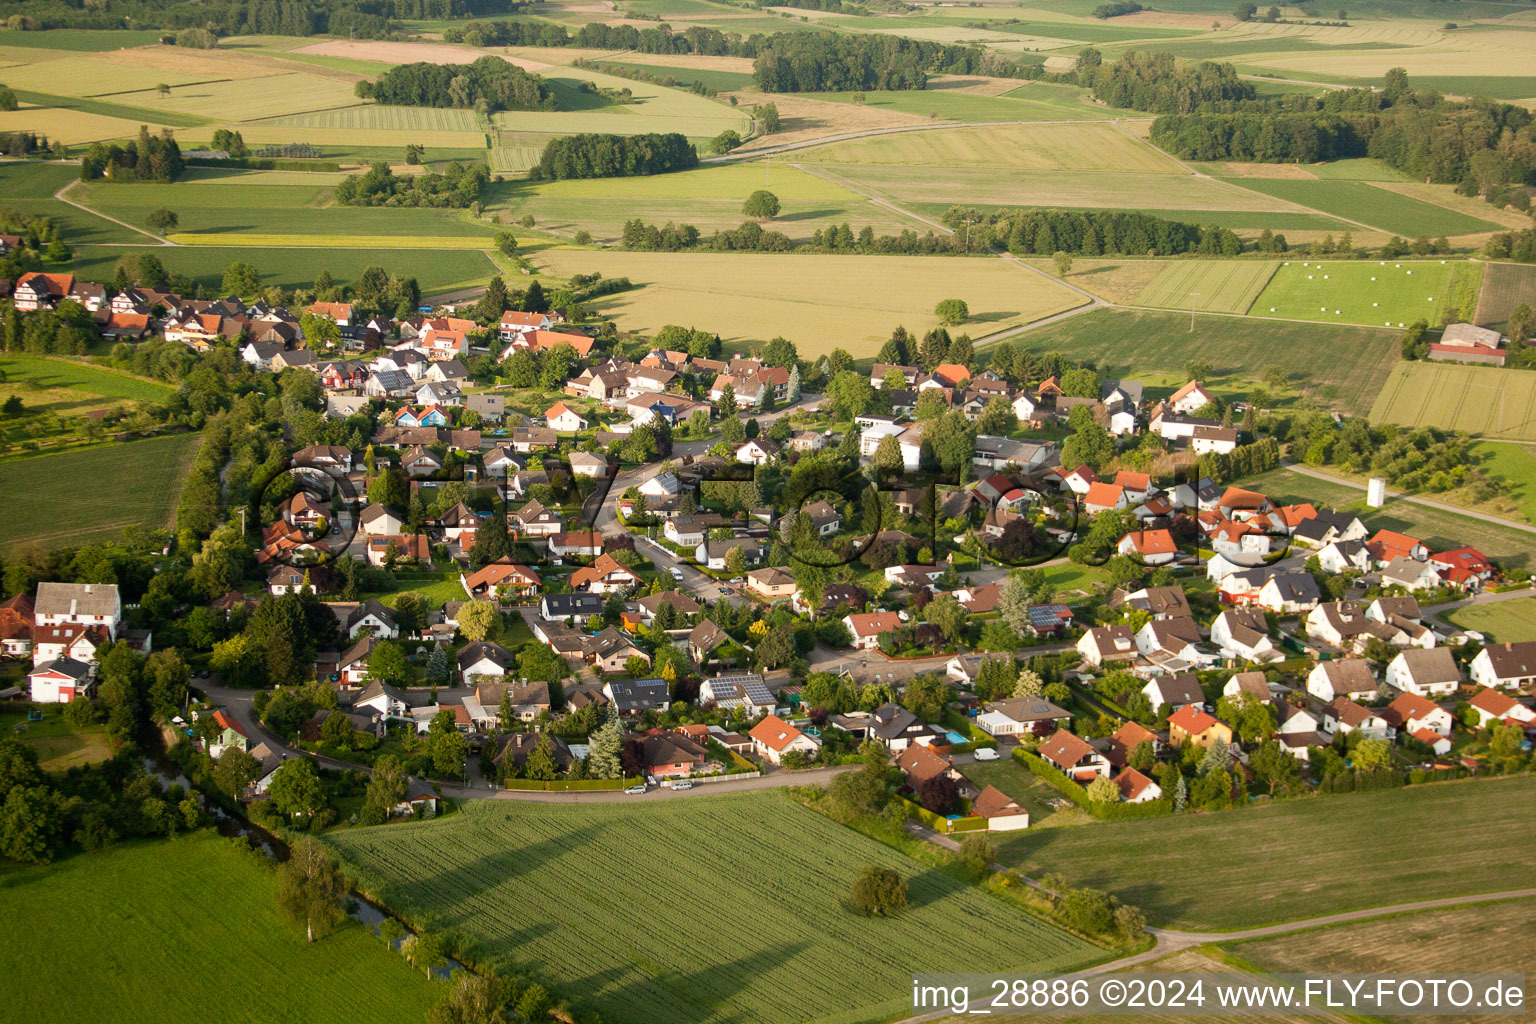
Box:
942, 206, 1243, 256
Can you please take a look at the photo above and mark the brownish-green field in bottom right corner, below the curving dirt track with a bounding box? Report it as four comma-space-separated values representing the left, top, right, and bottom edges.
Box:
1221, 900, 1536, 1024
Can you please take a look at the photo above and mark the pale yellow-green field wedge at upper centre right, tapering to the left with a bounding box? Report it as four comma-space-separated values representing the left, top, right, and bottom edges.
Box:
805, 124, 1189, 173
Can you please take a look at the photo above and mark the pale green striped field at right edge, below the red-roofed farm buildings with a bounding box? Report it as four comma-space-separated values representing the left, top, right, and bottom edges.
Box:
1370, 361, 1536, 441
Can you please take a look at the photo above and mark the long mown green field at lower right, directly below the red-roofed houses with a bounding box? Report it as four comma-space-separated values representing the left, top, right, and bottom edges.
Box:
998, 775, 1536, 930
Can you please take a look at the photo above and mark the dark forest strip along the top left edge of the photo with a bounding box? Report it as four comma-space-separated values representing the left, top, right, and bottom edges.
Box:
5, 0, 524, 38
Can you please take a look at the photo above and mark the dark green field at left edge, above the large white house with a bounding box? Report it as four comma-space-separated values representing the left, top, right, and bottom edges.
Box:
0, 434, 198, 551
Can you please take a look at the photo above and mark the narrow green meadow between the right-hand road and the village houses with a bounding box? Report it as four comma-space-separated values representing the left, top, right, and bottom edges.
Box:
1243, 468, 1536, 573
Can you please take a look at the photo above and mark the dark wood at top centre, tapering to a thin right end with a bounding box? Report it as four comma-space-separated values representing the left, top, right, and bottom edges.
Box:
753, 32, 1043, 92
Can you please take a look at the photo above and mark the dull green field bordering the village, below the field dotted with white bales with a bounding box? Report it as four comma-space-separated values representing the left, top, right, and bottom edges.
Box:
1012, 308, 1398, 416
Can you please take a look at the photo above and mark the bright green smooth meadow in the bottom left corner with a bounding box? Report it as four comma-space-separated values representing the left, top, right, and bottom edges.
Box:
0, 832, 441, 1024
